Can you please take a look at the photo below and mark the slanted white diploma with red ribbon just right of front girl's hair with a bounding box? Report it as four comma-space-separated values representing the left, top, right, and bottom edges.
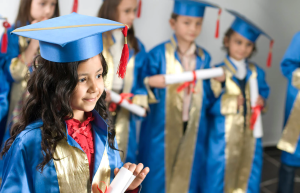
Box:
110, 91, 146, 117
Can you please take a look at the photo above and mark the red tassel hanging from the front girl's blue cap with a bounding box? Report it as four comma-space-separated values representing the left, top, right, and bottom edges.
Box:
117, 25, 129, 79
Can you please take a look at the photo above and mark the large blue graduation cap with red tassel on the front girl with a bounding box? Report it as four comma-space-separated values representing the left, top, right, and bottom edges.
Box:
12, 13, 129, 78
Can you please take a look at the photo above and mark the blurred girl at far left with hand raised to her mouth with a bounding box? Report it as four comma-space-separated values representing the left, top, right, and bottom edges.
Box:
0, 0, 59, 145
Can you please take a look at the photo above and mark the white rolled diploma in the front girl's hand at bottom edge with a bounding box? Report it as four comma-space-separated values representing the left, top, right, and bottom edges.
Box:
107, 167, 133, 193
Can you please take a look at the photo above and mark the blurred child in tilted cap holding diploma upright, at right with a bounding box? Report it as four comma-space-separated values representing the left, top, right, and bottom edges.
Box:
205, 11, 271, 193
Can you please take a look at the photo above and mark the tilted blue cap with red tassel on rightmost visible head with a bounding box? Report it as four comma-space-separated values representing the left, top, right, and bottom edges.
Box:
226, 9, 274, 67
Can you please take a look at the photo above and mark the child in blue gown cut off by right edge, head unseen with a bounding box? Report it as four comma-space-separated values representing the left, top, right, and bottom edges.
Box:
277, 32, 300, 193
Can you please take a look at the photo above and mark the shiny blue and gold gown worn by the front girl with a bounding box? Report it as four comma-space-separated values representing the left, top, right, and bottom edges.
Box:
0, 111, 122, 193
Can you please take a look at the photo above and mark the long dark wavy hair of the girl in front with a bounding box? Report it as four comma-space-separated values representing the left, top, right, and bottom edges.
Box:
1, 54, 116, 171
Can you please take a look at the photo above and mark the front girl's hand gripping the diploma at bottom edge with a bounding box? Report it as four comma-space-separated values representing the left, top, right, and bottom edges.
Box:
114, 163, 150, 190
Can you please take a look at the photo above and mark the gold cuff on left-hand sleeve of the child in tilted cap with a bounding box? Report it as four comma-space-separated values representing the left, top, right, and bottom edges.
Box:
221, 94, 238, 115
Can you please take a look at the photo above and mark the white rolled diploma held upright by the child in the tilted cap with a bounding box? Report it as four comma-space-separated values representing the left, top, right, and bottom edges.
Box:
249, 78, 263, 138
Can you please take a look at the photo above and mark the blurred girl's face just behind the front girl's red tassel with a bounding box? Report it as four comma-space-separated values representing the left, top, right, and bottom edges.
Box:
117, 0, 137, 28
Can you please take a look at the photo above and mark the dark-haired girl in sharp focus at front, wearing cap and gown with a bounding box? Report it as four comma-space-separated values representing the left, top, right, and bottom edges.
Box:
1, 13, 149, 193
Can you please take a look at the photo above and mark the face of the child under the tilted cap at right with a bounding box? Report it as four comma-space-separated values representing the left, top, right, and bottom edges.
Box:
225, 32, 254, 60
